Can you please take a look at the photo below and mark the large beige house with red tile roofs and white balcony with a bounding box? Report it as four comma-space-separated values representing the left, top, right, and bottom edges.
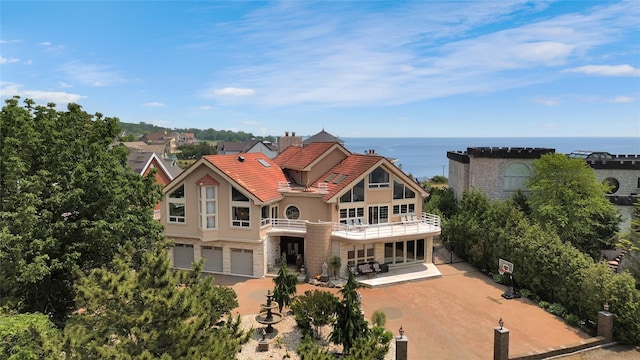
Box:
161, 141, 440, 277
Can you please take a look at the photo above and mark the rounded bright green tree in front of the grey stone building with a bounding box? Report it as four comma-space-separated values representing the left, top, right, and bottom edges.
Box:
529, 154, 620, 259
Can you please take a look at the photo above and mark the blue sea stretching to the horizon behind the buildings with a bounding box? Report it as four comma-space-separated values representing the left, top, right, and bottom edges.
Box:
342, 137, 640, 180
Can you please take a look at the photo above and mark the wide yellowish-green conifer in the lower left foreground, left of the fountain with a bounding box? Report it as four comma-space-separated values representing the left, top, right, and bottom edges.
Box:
64, 246, 252, 359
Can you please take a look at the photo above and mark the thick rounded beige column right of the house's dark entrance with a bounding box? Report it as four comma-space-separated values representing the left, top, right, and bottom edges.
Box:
304, 221, 332, 279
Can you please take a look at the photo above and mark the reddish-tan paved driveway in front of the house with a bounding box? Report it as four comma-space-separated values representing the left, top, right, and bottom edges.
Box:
216, 263, 588, 360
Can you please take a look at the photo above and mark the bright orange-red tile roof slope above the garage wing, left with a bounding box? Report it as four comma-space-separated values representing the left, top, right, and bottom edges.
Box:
203, 153, 287, 202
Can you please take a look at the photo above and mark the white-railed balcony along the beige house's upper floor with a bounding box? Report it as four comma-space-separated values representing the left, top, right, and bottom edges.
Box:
268, 213, 440, 240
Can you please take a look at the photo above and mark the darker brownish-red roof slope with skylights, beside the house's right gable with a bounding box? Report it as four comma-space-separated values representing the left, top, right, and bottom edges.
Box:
313, 154, 384, 200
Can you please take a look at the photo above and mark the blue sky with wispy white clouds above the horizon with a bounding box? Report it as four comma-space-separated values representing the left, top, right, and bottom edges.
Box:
0, 0, 640, 137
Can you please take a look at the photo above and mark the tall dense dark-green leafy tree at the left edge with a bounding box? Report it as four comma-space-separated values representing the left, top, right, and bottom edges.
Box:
0, 97, 162, 323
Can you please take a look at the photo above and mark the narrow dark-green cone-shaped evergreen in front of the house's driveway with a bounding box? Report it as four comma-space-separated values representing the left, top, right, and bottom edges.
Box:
330, 272, 369, 354
